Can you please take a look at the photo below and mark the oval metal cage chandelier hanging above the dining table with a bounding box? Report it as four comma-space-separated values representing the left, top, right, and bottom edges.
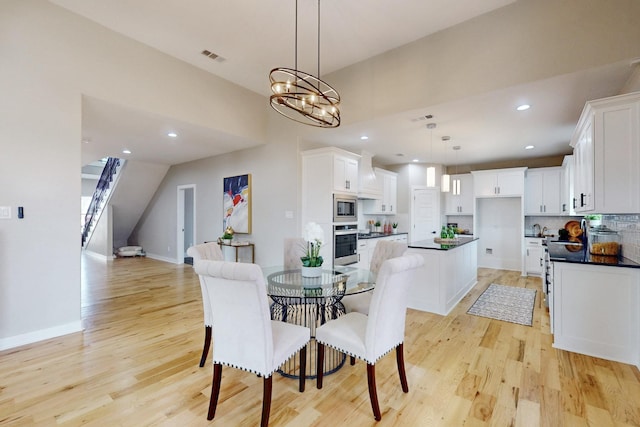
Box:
269, 0, 340, 128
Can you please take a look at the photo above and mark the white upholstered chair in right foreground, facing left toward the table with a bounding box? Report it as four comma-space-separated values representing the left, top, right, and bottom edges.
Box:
316, 254, 424, 421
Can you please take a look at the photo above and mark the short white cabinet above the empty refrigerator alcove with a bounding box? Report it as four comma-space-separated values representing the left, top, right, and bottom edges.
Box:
471, 168, 527, 197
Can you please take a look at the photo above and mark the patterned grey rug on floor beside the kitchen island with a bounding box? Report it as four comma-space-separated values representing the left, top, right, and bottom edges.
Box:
467, 283, 536, 326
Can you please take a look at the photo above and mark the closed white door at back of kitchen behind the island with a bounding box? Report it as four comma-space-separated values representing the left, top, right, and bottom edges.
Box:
409, 187, 440, 243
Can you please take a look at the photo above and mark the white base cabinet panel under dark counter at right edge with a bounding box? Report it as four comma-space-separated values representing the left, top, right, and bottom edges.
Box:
549, 262, 640, 366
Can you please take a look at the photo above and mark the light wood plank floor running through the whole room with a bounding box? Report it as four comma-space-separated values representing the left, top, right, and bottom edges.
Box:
0, 257, 640, 427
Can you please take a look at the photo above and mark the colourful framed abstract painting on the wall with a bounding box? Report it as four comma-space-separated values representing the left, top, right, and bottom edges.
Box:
222, 174, 251, 233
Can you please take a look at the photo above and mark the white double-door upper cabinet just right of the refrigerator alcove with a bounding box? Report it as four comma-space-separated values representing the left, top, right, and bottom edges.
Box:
524, 167, 562, 215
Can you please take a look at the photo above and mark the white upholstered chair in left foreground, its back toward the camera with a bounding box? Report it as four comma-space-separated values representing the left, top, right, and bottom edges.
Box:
194, 260, 311, 426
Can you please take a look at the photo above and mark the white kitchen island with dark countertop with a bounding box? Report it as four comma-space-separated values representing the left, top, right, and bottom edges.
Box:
407, 236, 478, 316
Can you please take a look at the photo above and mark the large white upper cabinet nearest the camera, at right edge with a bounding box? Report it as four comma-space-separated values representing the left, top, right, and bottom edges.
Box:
571, 92, 640, 214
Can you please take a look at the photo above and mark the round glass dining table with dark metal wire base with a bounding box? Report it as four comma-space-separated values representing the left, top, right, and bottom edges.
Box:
262, 266, 376, 378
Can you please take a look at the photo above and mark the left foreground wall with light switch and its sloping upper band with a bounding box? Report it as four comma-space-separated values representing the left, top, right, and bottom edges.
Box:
0, 0, 268, 349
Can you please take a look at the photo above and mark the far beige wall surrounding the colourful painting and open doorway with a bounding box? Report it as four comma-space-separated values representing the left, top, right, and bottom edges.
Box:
134, 121, 304, 267
